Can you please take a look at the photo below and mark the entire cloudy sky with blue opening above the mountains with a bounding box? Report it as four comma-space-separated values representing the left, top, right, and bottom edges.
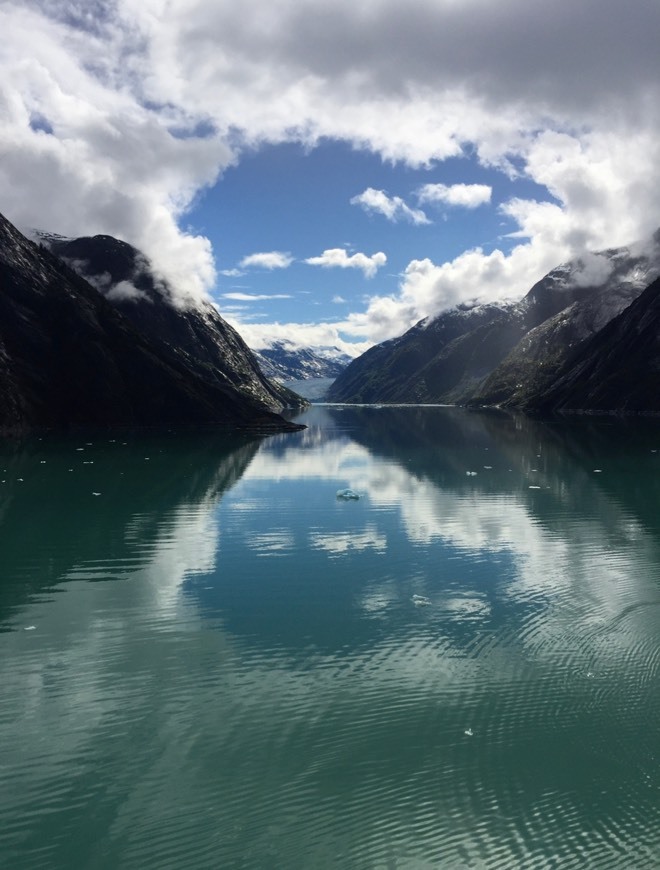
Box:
0, 0, 660, 355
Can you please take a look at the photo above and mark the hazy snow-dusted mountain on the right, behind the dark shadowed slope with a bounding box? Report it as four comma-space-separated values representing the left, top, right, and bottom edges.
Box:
328, 233, 660, 406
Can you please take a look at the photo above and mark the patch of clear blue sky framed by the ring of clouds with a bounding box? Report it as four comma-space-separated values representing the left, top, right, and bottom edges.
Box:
187, 140, 552, 337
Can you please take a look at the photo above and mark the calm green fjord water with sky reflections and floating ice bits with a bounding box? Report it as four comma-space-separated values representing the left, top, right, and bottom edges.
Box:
0, 408, 660, 870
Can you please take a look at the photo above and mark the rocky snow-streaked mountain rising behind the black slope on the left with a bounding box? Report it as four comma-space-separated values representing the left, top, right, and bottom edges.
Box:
41, 234, 304, 411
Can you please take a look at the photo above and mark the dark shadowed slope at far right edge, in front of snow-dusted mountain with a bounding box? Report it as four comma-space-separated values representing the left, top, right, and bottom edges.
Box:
528, 278, 660, 414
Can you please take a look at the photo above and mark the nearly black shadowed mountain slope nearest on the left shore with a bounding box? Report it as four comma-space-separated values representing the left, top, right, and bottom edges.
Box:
0, 215, 298, 431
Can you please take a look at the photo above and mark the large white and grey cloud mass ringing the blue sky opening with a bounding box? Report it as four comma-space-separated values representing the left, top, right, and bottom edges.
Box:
0, 0, 660, 339
